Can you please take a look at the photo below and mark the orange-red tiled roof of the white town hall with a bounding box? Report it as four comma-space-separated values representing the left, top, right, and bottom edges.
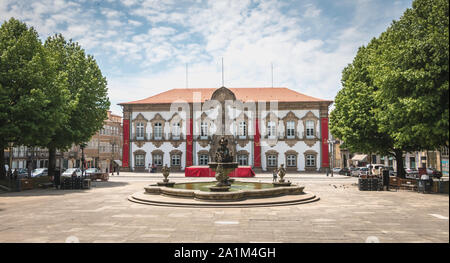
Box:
119, 88, 332, 105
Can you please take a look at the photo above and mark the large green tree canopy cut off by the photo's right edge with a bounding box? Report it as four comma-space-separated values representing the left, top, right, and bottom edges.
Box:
370, 0, 449, 150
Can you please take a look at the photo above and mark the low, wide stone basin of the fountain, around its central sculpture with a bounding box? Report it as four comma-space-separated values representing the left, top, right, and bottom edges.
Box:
145, 181, 304, 201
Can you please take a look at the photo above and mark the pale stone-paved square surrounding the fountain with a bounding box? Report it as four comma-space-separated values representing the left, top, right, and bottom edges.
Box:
0, 173, 449, 243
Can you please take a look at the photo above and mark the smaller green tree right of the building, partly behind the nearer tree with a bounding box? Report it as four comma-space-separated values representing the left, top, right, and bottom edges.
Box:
330, 43, 403, 175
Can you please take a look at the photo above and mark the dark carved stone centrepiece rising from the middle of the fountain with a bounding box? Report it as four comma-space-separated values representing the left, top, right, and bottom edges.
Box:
209, 137, 238, 192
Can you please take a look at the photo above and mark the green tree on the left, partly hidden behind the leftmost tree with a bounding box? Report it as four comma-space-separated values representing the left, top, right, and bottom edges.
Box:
44, 34, 110, 175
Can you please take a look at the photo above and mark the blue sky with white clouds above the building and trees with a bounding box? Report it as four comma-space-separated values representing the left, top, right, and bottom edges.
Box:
0, 0, 412, 115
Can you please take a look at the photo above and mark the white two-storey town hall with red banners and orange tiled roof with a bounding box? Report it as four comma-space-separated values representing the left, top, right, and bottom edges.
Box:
119, 87, 332, 172
